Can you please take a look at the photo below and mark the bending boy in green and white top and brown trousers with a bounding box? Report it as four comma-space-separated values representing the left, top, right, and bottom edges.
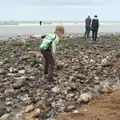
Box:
40, 26, 64, 81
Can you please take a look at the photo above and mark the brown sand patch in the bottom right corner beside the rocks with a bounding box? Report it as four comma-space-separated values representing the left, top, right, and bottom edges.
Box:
56, 91, 120, 120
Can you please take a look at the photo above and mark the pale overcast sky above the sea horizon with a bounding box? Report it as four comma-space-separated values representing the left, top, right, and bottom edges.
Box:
0, 0, 120, 21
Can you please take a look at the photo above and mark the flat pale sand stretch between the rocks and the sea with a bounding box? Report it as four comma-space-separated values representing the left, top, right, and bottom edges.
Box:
0, 23, 120, 39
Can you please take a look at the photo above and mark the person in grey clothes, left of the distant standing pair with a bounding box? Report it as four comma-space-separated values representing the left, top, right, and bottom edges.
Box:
85, 16, 91, 37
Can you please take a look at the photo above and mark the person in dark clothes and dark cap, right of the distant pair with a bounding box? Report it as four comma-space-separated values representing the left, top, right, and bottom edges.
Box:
91, 15, 99, 41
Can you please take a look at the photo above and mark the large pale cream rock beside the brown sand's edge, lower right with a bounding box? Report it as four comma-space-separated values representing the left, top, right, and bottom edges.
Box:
77, 92, 92, 103
